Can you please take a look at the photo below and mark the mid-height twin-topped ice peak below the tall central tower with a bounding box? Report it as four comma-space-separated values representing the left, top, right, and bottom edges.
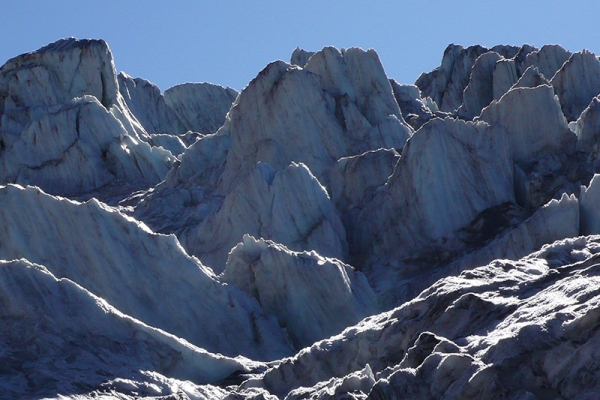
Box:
182, 163, 348, 272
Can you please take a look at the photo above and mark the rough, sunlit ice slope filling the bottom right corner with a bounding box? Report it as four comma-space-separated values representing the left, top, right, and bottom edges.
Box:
230, 236, 600, 399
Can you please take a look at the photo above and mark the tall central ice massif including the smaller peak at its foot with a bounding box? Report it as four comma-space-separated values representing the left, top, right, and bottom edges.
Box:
135, 48, 413, 272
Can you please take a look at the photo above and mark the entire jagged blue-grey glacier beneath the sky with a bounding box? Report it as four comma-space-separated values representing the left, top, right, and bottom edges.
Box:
0, 38, 600, 400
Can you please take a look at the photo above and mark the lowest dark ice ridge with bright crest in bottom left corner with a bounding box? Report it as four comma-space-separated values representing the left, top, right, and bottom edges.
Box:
0, 260, 258, 398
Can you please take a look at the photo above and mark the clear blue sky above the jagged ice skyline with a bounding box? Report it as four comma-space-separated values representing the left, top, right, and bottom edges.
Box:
0, 0, 600, 90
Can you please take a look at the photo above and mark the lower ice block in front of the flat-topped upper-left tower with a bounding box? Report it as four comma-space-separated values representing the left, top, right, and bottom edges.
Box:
0, 91, 173, 196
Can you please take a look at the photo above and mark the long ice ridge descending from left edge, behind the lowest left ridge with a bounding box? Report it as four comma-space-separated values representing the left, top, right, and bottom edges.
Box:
0, 185, 289, 359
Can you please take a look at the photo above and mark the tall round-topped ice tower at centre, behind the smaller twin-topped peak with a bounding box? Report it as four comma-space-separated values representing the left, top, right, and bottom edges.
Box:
218, 57, 347, 193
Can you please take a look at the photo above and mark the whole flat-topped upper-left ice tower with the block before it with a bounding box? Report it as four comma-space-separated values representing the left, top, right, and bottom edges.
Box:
0, 38, 174, 202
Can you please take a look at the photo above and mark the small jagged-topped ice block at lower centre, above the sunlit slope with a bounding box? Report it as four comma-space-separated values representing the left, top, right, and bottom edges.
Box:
223, 235, 377, 348
